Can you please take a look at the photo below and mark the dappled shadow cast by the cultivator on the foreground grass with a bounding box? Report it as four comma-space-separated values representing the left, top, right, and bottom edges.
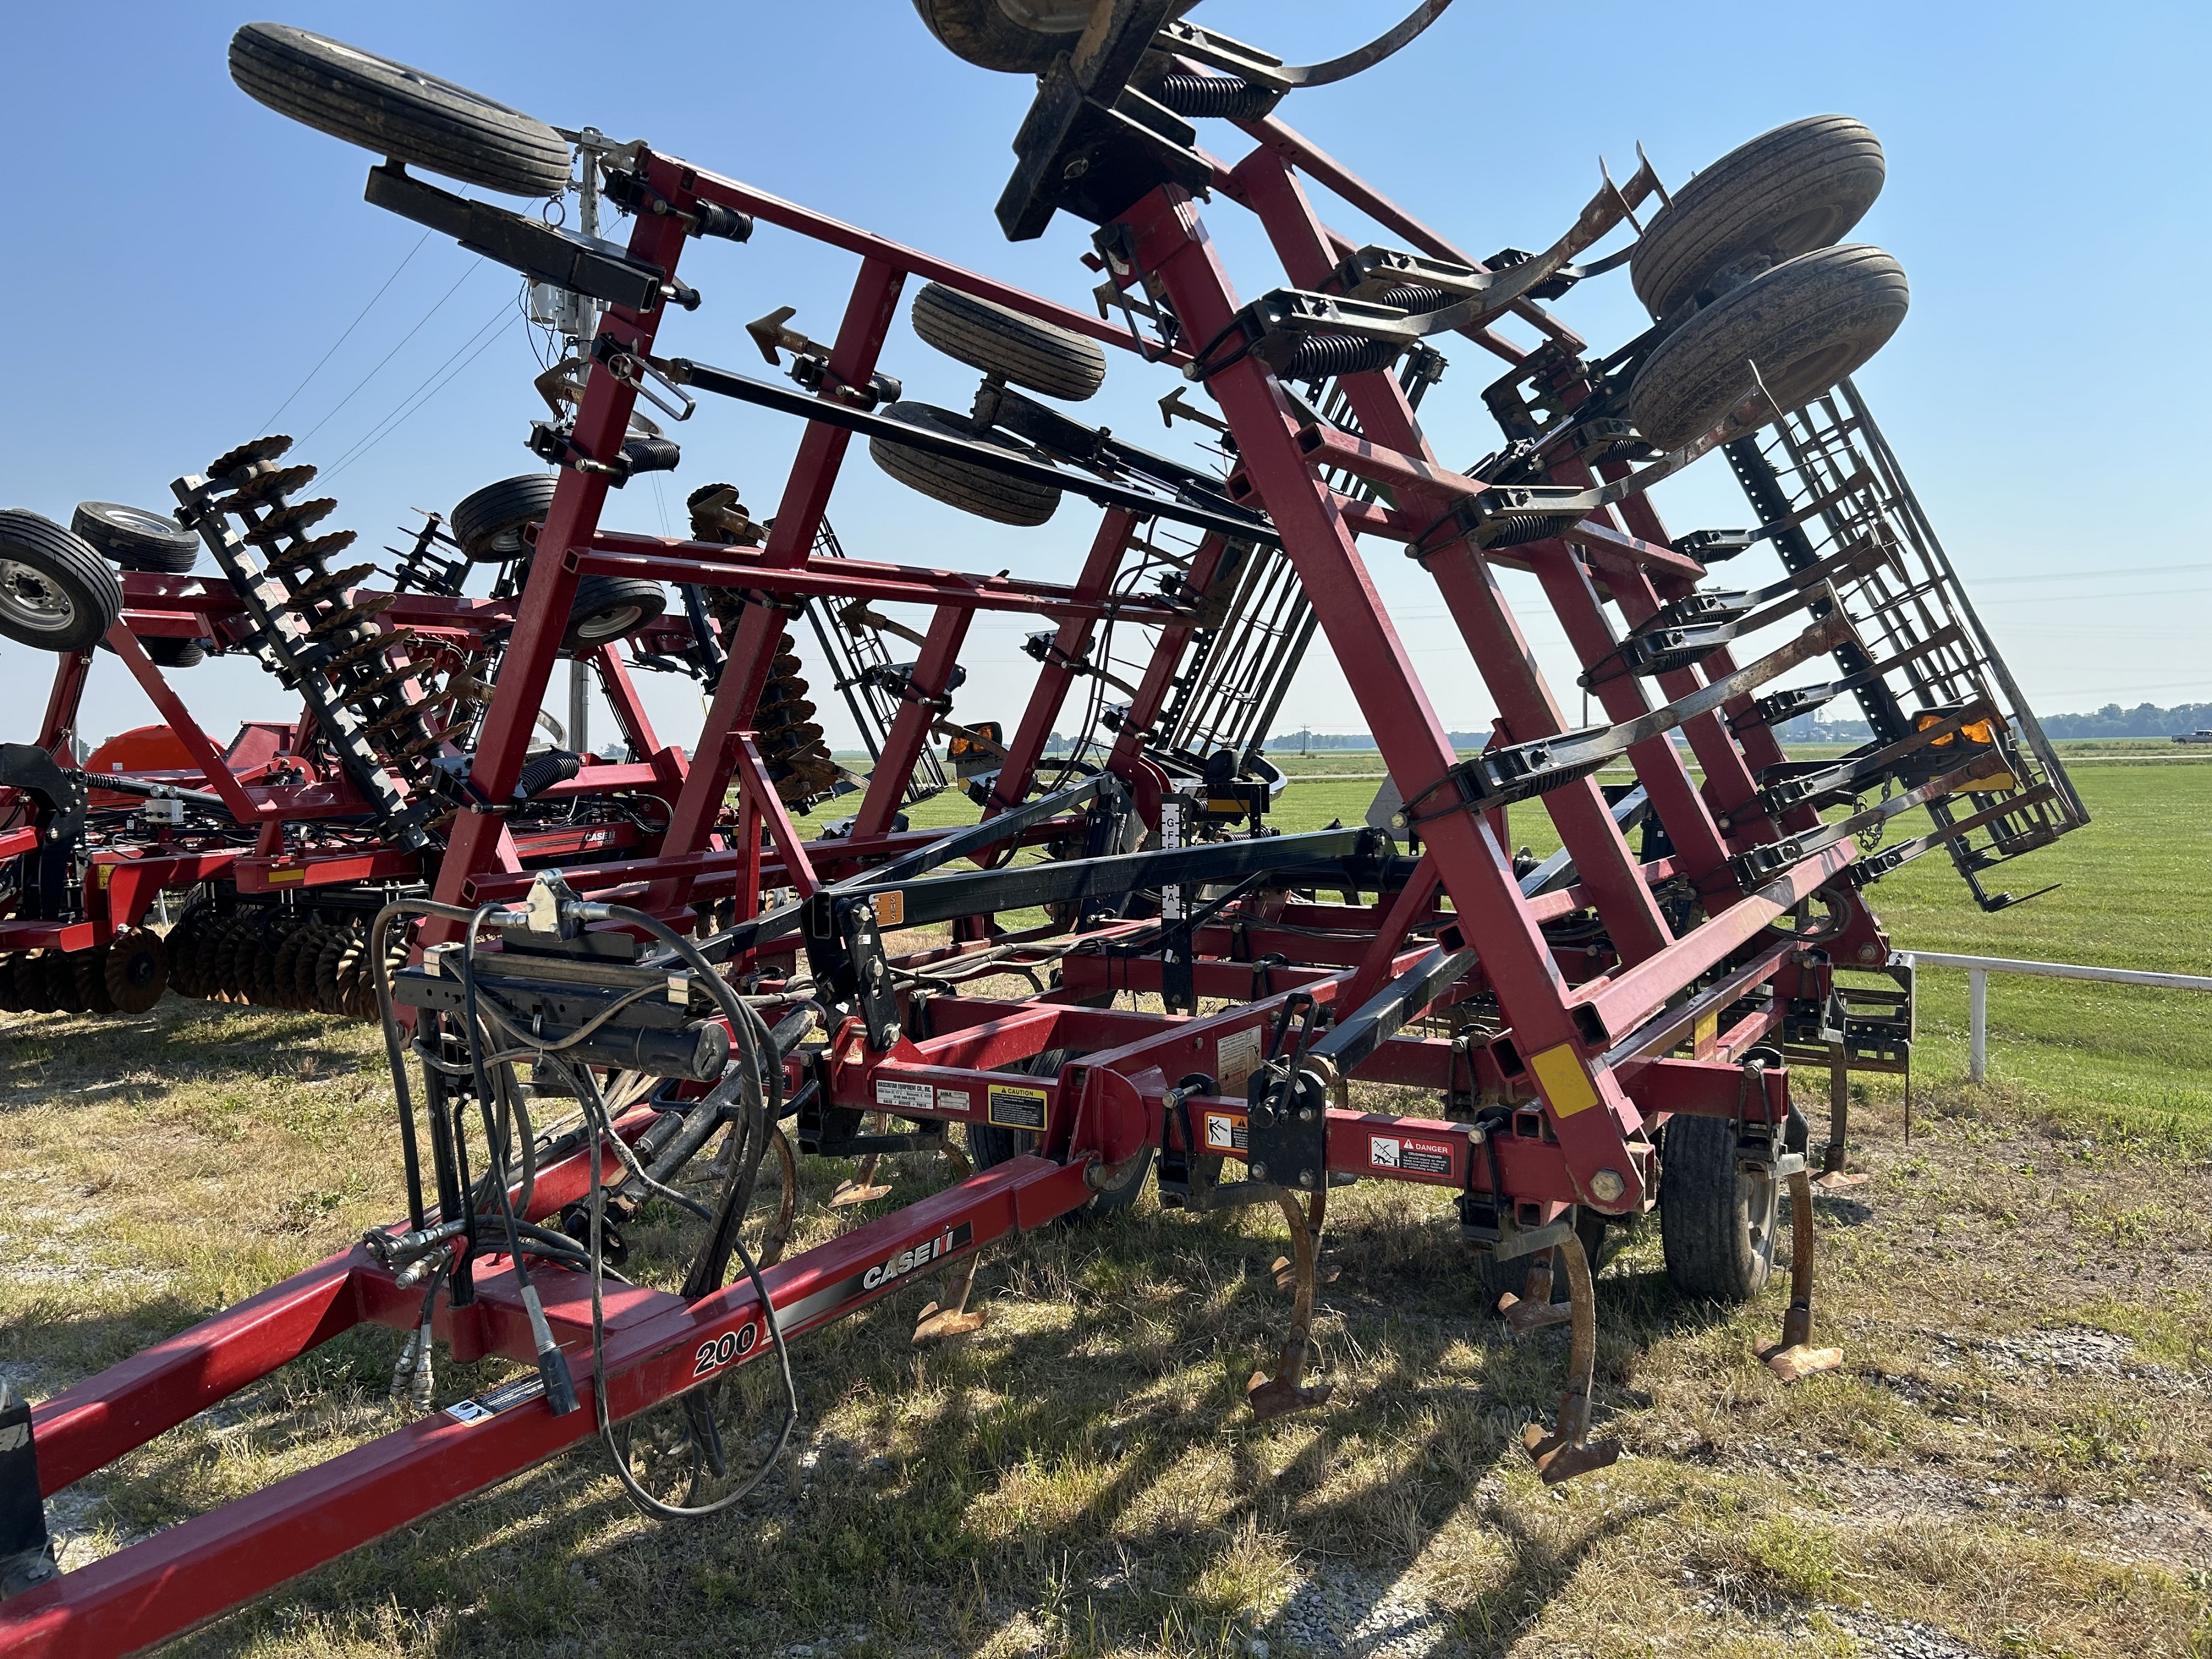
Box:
112, 1161, 1727, 1652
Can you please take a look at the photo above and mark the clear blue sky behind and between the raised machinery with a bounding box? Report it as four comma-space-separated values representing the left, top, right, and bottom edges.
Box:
0, 0, 2212, 745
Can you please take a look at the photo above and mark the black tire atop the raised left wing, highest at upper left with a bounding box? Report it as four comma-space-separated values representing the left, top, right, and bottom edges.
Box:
230, 22, 569, 197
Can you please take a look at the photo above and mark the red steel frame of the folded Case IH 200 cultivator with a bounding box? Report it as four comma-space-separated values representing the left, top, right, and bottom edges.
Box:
0, 119, 1887, 1655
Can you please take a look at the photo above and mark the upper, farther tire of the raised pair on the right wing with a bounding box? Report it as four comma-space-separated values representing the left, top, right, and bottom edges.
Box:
1628, 115, 1885, 319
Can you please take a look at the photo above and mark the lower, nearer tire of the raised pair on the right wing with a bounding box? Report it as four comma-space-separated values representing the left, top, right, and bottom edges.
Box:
1628, 243, 1911, 449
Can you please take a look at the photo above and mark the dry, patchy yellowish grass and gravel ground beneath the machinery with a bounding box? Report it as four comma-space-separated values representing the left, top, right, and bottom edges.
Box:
0, 998, 2212, 1659
